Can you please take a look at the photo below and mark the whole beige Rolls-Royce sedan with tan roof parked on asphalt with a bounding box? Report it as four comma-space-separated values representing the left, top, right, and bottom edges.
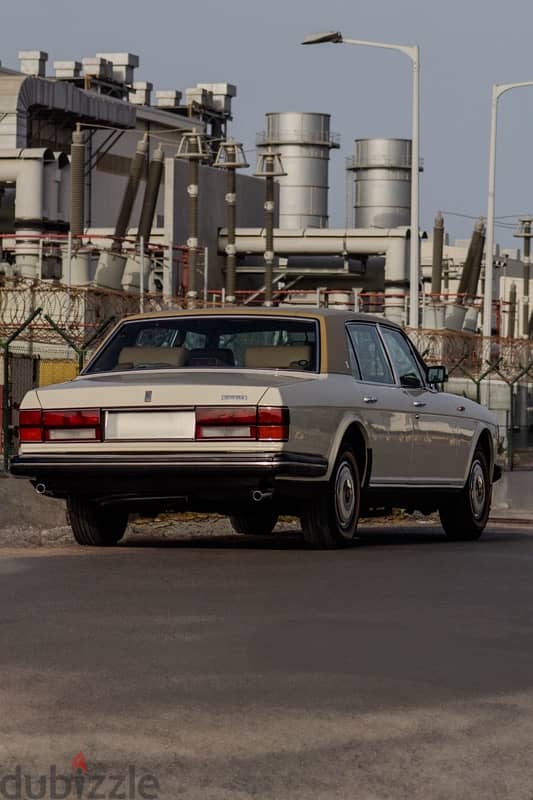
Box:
11, 307, 501, 548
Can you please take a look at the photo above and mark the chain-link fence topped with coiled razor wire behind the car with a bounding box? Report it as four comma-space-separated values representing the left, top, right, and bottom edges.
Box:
0, 279, 533, 468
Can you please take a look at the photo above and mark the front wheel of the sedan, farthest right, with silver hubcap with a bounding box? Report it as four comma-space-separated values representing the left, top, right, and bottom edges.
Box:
439, 447, 492, 542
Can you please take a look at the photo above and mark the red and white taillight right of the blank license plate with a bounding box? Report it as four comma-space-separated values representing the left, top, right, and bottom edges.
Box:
196, 406, 289, 441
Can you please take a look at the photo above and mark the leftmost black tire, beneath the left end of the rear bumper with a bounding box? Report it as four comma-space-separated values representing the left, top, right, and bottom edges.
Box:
67, 497, 128, 547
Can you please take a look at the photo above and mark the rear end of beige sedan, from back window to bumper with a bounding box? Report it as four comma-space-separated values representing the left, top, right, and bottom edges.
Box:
11, 314, 327, 511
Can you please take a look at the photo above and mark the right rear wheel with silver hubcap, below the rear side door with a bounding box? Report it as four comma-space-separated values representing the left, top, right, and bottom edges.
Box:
300, 444, 361, 549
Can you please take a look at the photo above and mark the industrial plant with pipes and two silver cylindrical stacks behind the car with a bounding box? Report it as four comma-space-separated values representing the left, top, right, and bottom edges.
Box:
0, 50, 533, 467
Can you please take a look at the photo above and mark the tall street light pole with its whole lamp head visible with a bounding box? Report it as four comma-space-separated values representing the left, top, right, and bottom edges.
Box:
302, 31, 420, 329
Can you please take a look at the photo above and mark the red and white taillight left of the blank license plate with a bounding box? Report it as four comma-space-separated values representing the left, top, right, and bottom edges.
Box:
19, 408, 102, 442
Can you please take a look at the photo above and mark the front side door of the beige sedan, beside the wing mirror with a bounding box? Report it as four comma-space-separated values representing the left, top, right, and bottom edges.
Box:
380, 325, 460, 485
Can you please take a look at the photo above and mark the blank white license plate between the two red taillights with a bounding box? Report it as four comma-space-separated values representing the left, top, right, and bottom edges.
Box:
105, 411, 196, 440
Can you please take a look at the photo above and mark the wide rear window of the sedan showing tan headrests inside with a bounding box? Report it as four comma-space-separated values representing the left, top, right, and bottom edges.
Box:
84, 316, 319, 374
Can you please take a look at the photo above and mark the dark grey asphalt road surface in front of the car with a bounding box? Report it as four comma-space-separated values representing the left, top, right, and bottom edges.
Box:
0, 525, 533, 800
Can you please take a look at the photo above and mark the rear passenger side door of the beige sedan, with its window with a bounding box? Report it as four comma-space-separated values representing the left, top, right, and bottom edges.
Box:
347, 322, 415, 486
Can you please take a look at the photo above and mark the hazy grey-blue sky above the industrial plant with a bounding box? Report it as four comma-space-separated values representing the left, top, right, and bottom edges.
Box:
4, 0, 533, 246
